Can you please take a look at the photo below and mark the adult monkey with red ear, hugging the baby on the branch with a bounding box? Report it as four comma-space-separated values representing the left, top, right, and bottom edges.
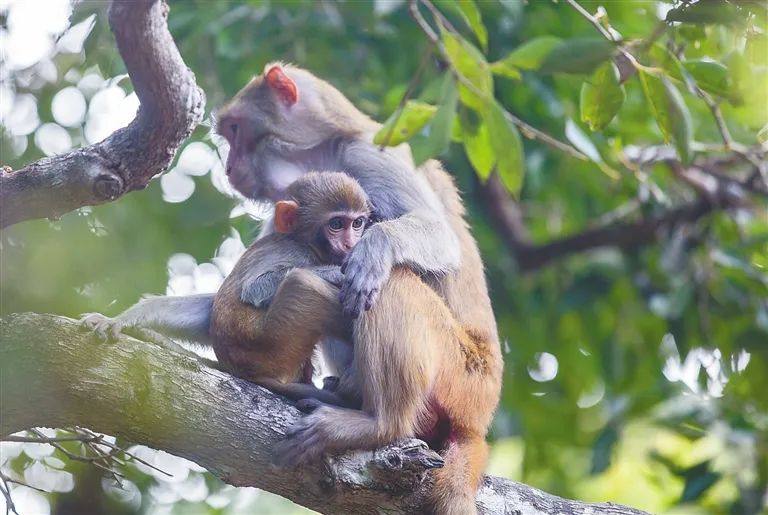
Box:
218, 64, 503, 515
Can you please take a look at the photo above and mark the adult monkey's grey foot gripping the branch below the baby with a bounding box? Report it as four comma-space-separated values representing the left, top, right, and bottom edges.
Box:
274, 406, 338, 467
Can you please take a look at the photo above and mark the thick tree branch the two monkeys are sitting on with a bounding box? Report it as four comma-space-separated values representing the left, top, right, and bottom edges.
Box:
0, 314, 642, 515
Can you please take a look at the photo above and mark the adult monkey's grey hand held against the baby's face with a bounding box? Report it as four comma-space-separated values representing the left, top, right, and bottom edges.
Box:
339, 238, 394, 318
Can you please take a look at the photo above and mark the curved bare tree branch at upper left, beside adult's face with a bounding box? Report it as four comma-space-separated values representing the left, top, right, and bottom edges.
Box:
0, 0, 205, 228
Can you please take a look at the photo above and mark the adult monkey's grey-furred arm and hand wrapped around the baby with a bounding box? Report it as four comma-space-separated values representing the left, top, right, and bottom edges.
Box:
341, 141, 461, 317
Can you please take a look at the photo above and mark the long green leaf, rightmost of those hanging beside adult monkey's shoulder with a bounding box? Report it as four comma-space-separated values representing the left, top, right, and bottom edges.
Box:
483, 100, 525, 197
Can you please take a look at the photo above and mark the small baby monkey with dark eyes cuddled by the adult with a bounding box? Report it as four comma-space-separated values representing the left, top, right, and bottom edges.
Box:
83, 172, 369, 406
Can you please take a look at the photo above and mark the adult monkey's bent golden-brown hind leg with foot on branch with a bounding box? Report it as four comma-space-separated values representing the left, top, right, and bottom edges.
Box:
276, 270, 438, 464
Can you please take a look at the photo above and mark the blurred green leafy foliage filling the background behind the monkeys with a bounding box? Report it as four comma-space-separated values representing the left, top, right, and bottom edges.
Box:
0, 0, 768, 513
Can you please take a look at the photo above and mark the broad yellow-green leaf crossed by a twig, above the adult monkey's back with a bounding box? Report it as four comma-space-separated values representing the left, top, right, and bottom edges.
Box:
441, 26, 493, 111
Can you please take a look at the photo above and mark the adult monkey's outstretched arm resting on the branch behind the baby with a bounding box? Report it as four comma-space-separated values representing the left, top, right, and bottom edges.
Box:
80, 293, 215, 346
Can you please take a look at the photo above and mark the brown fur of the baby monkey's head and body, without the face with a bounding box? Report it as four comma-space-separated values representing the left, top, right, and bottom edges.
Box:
210, 173, 368, 405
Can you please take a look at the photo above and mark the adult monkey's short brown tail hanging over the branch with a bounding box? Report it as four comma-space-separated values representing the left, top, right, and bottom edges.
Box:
432, 436, 488, 515
